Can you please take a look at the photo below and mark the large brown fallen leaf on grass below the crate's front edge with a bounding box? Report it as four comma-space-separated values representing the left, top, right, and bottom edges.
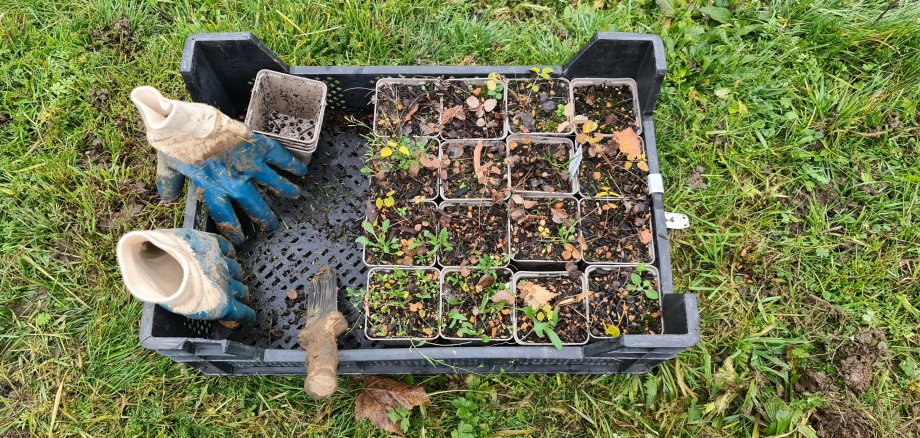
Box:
355, 376, 430, 436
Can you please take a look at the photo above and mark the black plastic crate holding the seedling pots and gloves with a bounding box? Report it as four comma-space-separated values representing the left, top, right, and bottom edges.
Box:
140, 33, 699, 375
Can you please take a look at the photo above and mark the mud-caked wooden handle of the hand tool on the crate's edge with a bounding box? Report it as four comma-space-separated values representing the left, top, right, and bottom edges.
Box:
298, 312, 348, 399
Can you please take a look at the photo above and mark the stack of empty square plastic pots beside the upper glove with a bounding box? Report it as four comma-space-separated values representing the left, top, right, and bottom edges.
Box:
246, 70, 326, 164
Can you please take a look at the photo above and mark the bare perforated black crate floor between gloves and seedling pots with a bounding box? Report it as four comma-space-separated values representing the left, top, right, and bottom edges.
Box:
211, 113, 374, 349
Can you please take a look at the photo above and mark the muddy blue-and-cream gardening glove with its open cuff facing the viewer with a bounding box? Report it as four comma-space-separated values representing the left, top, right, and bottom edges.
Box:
116, 228, 256, 324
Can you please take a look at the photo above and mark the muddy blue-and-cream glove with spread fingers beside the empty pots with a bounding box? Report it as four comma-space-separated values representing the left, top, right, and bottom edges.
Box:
131, 86, 307, 245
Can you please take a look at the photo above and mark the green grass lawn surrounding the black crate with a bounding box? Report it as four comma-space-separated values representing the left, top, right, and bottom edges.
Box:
0, 0, 920, 437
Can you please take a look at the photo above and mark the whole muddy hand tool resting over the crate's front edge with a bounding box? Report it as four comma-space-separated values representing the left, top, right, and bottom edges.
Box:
297, 265, 348, 399
